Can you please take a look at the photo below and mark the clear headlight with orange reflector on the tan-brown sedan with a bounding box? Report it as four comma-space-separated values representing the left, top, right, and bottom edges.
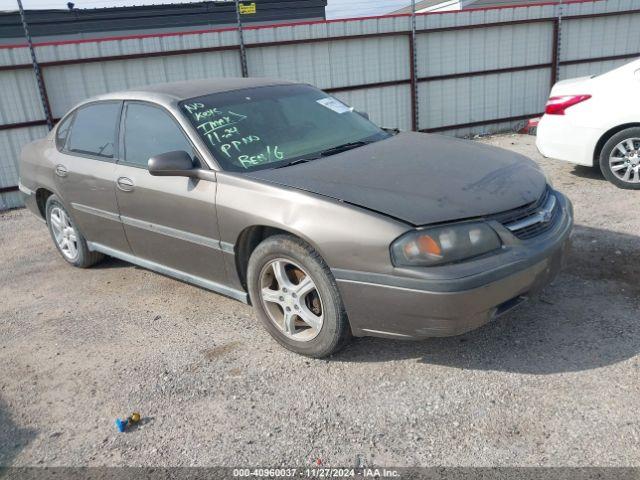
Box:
391, 222, 502, 267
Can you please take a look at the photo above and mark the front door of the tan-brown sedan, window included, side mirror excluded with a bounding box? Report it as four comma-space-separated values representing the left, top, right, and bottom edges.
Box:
116, 101, 226, 284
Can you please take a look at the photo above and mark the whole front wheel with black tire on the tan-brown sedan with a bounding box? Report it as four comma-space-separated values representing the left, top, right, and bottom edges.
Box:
247, 235, 351, 358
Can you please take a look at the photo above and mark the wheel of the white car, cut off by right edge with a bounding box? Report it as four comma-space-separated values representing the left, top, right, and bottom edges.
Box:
600, 127, 640, 190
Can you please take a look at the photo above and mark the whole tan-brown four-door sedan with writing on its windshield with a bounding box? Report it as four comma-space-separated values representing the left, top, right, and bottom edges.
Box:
20, 79, 573, 357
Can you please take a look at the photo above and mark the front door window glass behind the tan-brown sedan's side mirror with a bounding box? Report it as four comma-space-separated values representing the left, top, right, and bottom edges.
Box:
124, 103, 194, 168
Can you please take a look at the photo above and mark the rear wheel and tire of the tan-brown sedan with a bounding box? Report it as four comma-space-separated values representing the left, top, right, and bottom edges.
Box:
46, 195, 104, 268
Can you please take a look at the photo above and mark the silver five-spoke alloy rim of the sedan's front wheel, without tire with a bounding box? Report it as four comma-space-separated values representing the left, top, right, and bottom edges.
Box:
260, 258, 323, 342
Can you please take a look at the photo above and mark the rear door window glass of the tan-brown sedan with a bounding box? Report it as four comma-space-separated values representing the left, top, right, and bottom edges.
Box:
66, 102, 121, 158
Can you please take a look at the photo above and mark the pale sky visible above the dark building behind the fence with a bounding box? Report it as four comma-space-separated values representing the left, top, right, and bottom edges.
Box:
0, 0, 411, 19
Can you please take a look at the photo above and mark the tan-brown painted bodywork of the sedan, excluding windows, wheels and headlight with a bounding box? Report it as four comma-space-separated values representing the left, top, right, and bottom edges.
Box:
20, 79, 573, 356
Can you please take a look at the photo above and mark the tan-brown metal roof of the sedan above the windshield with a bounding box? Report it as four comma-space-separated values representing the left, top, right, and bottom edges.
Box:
93, 77, 293, 101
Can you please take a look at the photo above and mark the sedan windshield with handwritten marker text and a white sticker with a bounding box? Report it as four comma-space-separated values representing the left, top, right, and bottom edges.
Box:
180, 85, 390, 171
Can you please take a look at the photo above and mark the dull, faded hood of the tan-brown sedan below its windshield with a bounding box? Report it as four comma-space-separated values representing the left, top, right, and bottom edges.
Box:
244, 133, 546, 225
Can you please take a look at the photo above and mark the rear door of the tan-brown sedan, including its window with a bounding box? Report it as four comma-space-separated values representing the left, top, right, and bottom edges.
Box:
52, 101, 130, 252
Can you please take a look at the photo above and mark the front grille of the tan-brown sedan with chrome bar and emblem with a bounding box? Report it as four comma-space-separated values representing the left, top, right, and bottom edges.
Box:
494, 188, 560, 240
